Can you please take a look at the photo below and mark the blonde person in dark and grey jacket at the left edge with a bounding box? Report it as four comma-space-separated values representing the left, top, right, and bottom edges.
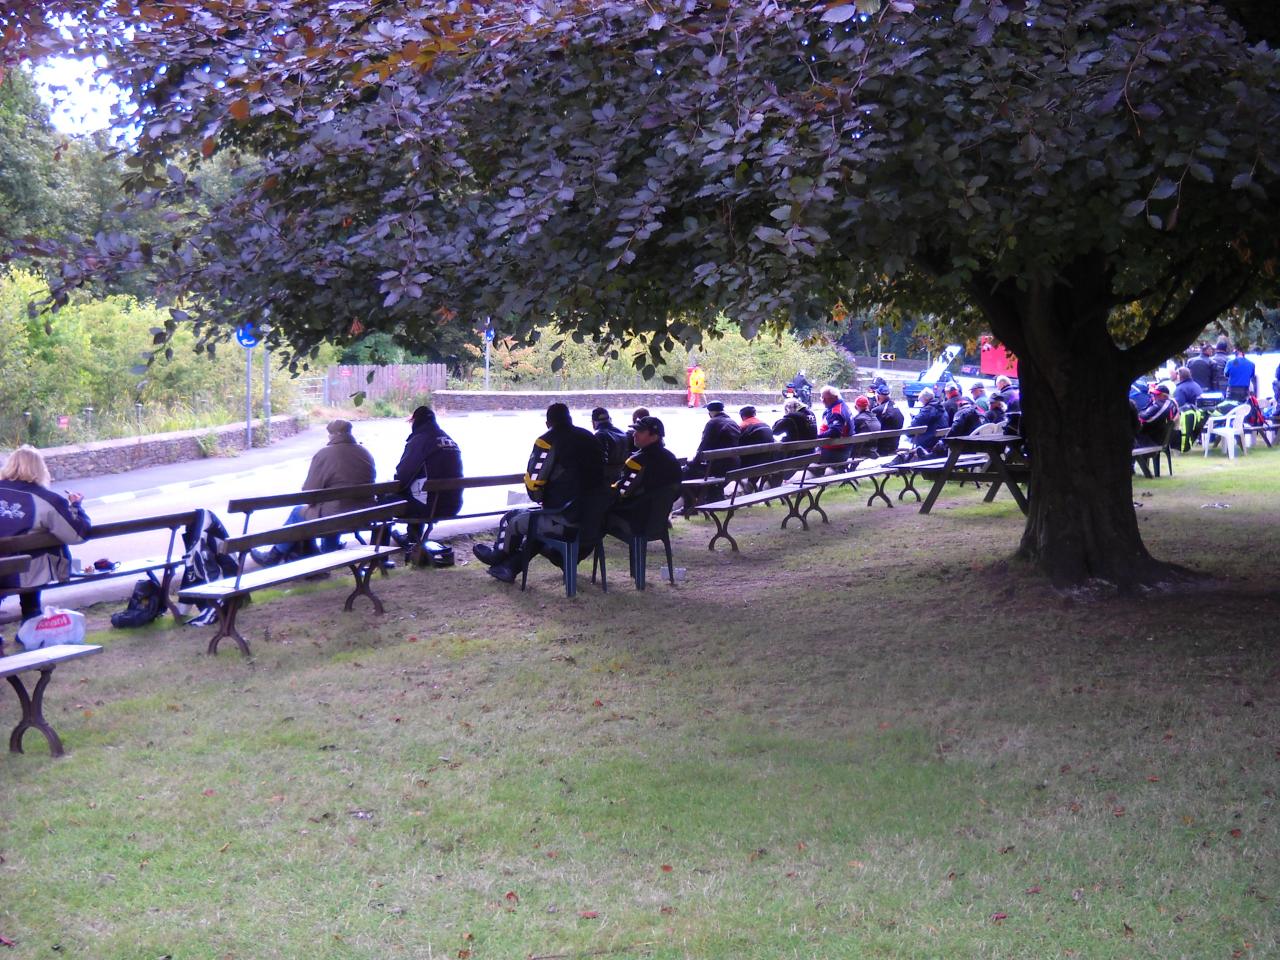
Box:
0, 444, 92, 620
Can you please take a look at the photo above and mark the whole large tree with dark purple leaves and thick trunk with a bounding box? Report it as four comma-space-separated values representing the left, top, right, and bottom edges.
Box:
15, 0, 1280, 588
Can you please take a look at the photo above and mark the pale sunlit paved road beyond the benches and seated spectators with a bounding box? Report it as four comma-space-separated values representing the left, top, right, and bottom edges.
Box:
0, 403, 782, 622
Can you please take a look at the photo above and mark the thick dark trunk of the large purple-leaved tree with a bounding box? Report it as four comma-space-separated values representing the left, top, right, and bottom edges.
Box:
996, 287, 1185, 591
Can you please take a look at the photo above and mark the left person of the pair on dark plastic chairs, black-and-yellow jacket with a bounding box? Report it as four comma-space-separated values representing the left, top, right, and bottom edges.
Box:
471, 403, 612, 584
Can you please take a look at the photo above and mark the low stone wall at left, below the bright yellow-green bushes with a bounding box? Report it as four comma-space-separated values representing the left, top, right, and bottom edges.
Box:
0, 416, 302, 480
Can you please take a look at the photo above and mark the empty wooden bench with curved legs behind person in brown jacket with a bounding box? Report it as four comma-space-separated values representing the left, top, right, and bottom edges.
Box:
178, 492, 401, 657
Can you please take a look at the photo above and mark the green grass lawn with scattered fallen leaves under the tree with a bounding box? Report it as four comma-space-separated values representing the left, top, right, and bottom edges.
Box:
0, 449, 1280, 960
